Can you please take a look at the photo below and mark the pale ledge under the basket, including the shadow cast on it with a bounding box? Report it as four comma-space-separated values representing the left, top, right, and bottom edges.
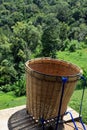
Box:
0, 105, 87, 130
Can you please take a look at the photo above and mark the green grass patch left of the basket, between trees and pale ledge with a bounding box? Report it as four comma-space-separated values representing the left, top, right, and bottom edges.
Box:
0, 92, 26, 109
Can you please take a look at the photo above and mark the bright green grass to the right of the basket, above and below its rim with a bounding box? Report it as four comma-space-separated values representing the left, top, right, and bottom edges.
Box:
57, 48, 87, 123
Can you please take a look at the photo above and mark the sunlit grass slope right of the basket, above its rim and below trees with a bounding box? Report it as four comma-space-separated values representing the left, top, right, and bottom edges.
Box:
57, 48, 87, 72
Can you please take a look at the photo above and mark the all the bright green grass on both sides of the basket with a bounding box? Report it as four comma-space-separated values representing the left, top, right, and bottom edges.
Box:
0, 48, 87, 123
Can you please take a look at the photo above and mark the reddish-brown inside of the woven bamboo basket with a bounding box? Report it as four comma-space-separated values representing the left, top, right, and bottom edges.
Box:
28, 59, 81, 76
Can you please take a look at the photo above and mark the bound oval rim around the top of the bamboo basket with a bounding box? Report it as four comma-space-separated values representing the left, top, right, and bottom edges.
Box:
25, 57, 83, 78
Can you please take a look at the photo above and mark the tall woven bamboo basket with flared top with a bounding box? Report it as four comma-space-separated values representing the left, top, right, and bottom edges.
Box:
25, 58, 82, 120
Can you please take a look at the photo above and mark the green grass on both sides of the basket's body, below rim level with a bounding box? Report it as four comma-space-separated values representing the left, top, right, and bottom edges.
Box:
0, 89, 87, 123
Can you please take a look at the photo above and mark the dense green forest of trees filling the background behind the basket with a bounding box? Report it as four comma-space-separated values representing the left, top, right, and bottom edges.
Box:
0, 0, 87, 96
